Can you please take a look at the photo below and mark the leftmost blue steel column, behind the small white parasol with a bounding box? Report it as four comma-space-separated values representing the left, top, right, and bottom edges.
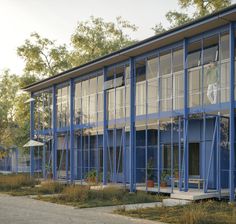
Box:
30, 93, 34, 176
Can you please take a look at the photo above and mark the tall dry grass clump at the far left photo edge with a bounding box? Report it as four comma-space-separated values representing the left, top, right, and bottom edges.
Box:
0, 174, 37, 191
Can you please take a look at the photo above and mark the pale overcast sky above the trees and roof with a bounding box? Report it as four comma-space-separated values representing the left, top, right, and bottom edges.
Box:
0, 0, 234, 74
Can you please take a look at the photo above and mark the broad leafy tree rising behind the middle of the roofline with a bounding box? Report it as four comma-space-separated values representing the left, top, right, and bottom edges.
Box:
71, 16, 137, 66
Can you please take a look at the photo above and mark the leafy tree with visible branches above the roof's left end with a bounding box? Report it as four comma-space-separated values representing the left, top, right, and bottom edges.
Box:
17, 33, 72, 79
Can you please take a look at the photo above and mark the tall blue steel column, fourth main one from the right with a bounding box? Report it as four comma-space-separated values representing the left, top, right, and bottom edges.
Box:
103, 67, 107, 185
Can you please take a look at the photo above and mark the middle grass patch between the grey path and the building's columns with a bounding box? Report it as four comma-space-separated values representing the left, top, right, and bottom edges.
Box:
39, 186, 166, 208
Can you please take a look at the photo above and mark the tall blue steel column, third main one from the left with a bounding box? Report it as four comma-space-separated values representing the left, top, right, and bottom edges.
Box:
70, 79, 75, 183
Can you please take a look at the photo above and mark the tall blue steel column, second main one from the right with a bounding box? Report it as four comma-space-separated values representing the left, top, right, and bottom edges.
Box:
183, 39, 188, 191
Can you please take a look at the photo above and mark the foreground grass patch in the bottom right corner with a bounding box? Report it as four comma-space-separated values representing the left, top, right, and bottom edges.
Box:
115, 200, 236, 224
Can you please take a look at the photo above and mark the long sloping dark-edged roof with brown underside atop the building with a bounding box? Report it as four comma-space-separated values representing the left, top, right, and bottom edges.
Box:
23, 4, 236, 92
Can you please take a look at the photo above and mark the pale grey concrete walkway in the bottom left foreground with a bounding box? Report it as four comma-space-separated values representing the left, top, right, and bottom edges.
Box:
0, 194, 164, 224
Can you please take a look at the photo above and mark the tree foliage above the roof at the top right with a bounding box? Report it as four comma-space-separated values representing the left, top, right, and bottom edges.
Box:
152, 0, 231, 34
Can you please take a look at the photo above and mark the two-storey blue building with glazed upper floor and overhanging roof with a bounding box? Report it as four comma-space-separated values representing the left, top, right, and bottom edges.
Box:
25, 5, 236, 201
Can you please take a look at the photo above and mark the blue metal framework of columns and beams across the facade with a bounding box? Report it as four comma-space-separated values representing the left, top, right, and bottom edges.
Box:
31, 17, 235, 200
